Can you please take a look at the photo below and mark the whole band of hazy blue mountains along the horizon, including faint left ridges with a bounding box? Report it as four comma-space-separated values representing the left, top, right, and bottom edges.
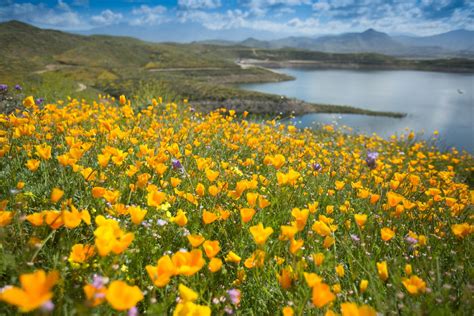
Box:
81, 23, 474, 58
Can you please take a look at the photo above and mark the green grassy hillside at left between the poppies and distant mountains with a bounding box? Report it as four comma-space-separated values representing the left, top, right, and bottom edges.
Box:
0, 22, 289, 105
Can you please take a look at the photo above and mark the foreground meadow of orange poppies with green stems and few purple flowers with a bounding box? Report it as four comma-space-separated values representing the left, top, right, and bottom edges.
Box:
0, 90, 474, 315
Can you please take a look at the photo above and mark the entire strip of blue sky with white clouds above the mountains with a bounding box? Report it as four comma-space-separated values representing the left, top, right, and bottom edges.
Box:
0, 0, 474, 38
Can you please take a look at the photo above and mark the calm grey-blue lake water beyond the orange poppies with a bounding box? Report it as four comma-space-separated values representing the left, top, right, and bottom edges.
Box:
241, 69, 474, 153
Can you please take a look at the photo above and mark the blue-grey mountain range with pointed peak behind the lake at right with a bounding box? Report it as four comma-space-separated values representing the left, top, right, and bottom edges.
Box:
197, 29, 474, 58
